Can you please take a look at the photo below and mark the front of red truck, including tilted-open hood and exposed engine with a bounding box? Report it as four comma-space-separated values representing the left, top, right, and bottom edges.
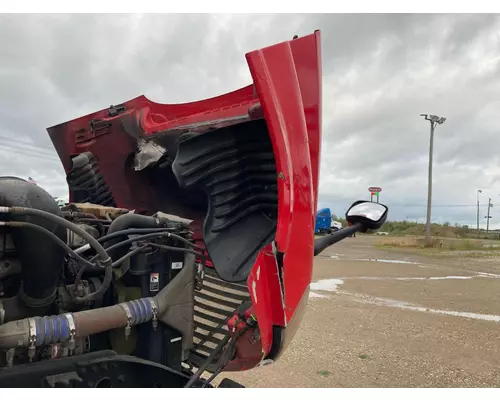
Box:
0, 32, 321, 387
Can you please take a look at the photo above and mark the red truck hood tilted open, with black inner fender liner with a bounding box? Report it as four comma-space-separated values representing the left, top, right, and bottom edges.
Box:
47, 31, 322, 368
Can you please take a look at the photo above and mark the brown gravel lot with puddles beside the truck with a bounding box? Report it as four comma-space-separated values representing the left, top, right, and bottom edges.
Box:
220, 236, 500, 387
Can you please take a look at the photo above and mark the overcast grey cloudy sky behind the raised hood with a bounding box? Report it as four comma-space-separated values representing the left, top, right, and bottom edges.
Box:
0, 14, 500, 225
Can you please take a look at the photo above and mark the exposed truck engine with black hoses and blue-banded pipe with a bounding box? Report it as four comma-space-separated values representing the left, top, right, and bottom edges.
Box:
0, 177, 253, 387
